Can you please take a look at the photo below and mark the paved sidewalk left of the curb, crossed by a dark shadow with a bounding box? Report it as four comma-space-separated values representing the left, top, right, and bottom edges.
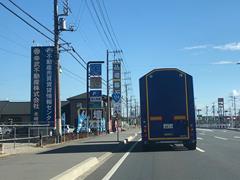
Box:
0, 129, 139, 180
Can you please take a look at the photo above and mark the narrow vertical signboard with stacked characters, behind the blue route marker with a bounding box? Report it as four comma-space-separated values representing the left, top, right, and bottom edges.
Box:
112, 61, 121, 117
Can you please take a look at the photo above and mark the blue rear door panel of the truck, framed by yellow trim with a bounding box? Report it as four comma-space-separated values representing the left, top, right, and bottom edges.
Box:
146, 69, 189, 140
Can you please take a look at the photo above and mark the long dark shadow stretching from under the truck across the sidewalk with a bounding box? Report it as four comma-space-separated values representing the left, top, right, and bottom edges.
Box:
39, 141, 190, 154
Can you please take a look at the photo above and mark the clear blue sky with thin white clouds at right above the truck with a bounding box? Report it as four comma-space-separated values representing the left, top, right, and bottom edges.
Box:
0, 0, 240, 112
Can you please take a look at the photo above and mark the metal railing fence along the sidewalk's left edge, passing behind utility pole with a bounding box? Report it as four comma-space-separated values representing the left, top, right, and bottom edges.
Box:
0, 124, 93, 149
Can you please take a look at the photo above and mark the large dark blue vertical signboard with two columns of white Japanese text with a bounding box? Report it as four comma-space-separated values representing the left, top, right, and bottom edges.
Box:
31, 46, 55, 126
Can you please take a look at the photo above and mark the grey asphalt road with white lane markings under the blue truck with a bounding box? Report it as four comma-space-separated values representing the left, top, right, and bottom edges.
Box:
86, 129, 240, 180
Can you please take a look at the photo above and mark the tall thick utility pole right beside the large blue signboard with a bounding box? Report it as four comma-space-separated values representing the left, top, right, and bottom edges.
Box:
54, 0, 62, 143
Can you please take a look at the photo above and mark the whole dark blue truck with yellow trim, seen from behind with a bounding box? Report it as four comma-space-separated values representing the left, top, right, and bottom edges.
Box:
139, 68, 197, 150
